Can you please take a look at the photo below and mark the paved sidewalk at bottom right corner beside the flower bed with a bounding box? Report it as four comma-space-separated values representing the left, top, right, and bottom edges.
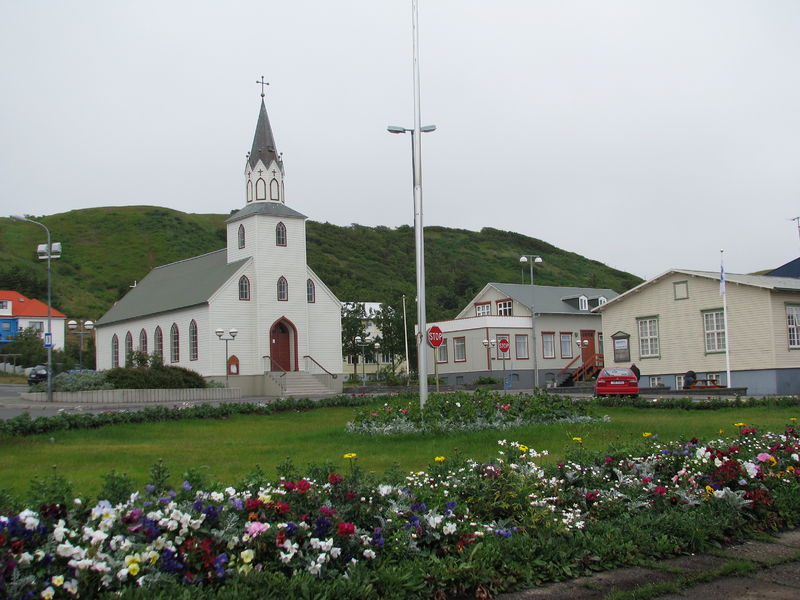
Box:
497, 529, 800, 600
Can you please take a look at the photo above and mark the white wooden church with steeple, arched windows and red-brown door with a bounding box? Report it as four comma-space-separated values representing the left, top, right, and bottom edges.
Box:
95, 93, 342, 396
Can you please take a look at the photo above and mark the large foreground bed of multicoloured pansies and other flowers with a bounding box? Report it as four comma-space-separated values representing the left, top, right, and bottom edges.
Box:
0, 422, 800, 598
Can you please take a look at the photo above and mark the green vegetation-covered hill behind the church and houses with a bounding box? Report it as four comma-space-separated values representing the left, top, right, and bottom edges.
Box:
0, 206, 642, 321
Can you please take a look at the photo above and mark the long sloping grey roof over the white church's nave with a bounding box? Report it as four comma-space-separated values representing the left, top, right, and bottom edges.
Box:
95, 248, 250, 327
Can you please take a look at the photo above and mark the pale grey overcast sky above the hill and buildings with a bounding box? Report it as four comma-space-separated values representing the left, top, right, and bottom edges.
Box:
0, 0, 800, 277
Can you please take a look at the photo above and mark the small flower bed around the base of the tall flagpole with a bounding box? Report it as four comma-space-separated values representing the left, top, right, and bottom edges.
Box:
346, 390, 597, 435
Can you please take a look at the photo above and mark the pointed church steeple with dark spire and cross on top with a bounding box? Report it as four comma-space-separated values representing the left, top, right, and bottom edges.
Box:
244, 77, 285, 204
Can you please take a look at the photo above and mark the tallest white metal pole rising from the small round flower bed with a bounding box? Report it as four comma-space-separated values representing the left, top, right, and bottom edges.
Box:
411, 0, 428, 408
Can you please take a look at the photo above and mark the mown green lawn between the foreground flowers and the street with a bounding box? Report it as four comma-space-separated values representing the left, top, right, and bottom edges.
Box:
0, 407, 800, 495
